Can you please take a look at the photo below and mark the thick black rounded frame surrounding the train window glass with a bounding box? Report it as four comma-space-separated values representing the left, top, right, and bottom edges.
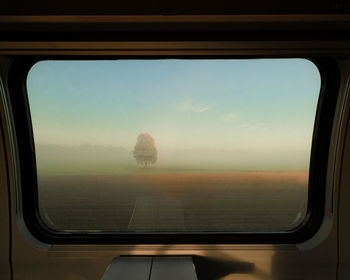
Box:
8, 55, 340, 244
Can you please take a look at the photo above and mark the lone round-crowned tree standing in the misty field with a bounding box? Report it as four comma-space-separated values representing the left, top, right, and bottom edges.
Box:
133, 133, 158, 168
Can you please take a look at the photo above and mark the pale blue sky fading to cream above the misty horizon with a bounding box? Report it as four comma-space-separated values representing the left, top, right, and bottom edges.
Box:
27, 59, 321, 169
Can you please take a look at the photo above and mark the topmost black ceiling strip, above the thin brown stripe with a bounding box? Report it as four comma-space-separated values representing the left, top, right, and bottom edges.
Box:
0, 0, 350, 15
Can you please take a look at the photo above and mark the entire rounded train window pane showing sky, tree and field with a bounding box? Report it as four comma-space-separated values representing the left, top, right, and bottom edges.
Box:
27, 59, 321, 233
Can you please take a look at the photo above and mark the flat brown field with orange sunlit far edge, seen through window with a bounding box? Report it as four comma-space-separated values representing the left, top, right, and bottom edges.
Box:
38, 172, 308, 232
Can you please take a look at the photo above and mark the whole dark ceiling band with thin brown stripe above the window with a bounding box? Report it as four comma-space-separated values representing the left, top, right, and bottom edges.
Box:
0, 0, 350, 43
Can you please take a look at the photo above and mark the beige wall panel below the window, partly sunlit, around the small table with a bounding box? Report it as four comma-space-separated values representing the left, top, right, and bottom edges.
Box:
13, 225, 337, 280
